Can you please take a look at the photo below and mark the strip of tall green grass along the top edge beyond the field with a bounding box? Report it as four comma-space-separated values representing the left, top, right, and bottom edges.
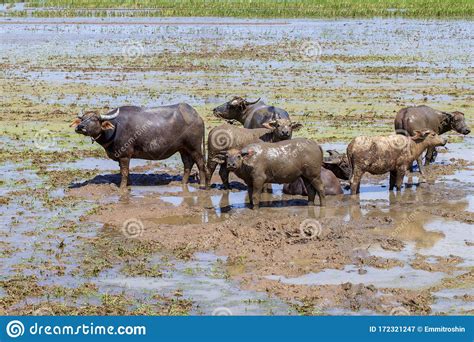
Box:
6, 0, 474, 18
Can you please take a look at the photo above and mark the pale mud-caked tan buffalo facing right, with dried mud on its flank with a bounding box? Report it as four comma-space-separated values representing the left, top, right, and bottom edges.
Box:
347, 130, 446, 194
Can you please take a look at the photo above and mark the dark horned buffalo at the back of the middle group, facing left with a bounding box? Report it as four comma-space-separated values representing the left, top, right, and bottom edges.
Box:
213, 97, 290, 128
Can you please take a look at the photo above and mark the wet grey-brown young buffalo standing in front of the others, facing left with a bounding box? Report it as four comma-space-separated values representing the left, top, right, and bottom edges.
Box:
215, 138, 325, 208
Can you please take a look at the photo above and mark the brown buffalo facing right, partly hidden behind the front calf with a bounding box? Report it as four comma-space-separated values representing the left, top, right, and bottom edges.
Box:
207, 119, 302, 189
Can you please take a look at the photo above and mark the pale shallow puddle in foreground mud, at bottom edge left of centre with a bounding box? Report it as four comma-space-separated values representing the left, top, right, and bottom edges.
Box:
98, 251, 293, 315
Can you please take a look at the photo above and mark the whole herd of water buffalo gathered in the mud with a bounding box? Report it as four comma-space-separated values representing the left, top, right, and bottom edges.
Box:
72, 97, 470, 208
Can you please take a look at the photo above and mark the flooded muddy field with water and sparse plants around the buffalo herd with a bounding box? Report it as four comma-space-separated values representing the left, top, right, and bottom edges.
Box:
0, 18, 474, 315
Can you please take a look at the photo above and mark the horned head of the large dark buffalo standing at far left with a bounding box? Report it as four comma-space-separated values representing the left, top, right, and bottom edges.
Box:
71, 108, 120, 139
